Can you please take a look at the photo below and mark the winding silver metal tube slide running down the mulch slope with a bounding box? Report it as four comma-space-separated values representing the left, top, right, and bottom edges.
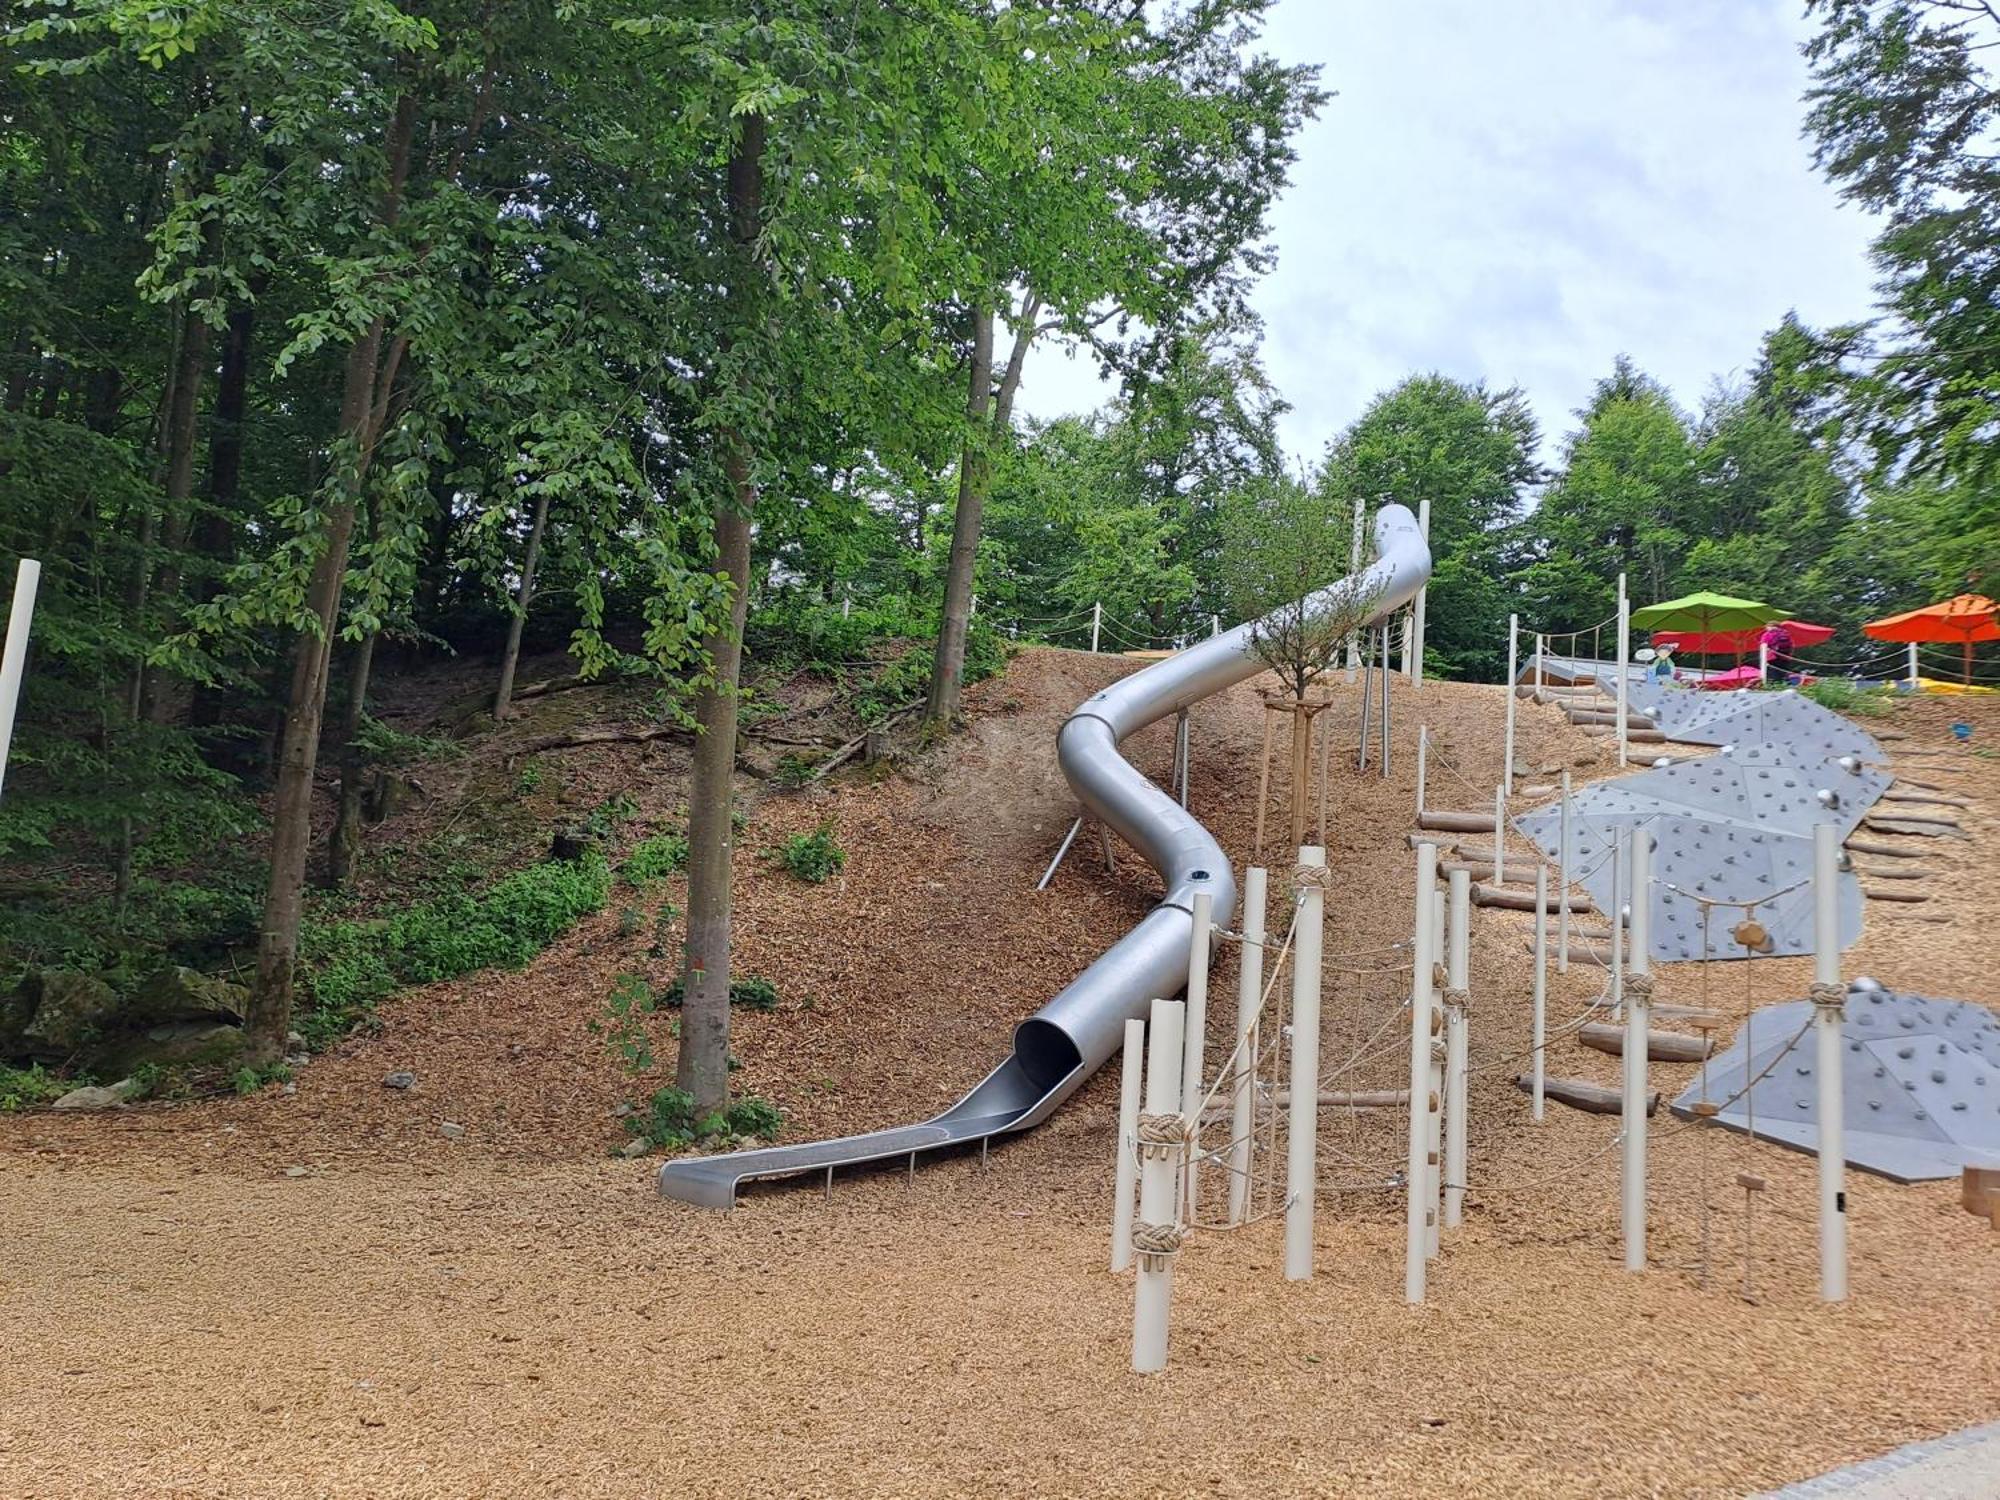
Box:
660, 506, 1430, 1208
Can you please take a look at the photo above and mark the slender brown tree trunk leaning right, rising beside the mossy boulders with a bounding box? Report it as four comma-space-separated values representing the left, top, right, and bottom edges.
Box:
244, 94, 416, 1064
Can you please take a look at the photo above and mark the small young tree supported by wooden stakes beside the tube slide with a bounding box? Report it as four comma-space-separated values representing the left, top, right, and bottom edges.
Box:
1220, 474, 1380, 848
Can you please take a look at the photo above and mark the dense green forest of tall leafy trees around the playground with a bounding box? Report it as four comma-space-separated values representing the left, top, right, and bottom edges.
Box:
0, 0, 2000, 1108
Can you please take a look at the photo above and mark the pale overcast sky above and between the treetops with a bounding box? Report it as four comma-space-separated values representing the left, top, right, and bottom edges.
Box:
1022, 0, 1872, 460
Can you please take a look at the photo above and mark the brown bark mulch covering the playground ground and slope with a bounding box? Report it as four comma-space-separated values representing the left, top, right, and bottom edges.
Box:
0, 652, 2000, 1496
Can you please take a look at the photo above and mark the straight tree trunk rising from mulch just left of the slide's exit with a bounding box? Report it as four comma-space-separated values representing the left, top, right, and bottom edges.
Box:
674, 114, 764, 1114
